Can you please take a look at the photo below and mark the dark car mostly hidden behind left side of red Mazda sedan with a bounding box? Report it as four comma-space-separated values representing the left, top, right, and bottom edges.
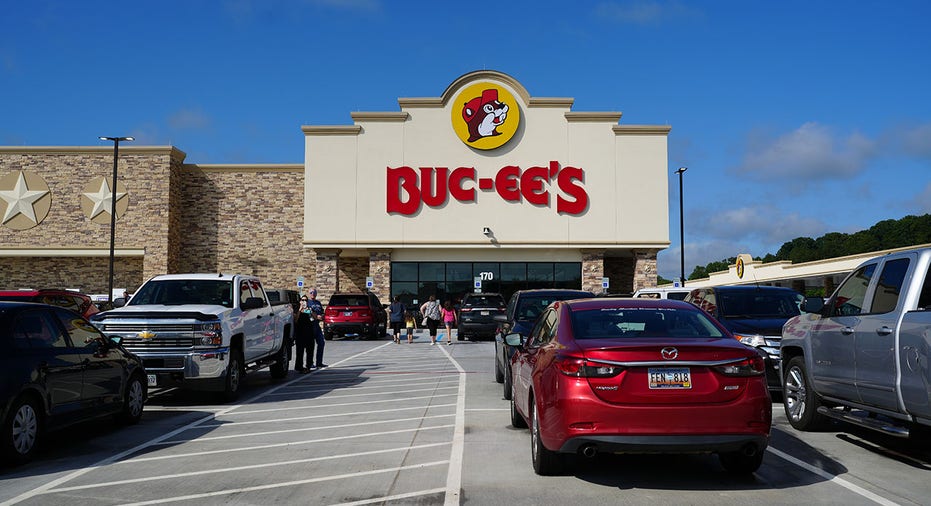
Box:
495, 288, 595, 399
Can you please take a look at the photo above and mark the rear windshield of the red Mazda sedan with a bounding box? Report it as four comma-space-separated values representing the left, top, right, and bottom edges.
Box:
572, 308, 724, 339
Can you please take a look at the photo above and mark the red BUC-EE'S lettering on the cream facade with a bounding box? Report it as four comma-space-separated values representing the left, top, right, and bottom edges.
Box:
387, 161, 588, 216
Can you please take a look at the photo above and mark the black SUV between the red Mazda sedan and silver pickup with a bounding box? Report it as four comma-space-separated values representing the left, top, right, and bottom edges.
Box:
685, 285, 805, 392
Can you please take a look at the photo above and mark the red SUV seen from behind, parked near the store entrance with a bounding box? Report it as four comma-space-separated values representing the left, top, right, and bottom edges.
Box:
323, 292, 388, 339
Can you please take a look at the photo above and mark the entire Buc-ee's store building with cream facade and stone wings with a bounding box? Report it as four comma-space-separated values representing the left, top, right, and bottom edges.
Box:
0, 71, 670, 303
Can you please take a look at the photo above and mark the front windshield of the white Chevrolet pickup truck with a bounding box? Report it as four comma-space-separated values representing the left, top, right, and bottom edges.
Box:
126, 279, 233, 307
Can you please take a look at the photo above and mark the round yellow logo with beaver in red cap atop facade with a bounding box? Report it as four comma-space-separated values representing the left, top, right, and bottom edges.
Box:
450, 82, 520, 150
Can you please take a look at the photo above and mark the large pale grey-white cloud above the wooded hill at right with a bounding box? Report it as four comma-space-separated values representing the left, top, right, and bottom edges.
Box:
731, 122, 876, 181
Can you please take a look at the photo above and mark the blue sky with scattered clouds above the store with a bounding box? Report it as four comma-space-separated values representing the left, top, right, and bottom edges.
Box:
0, 0, 931, 278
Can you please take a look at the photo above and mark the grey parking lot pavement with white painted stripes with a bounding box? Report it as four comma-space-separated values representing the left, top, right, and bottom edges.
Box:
0, 333, 931, 505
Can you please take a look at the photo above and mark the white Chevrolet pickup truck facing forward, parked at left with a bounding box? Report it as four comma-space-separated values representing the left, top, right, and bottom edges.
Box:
92, 274, 293, 401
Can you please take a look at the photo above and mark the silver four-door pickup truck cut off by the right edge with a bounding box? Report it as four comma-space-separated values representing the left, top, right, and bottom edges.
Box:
781, 248, 931, 441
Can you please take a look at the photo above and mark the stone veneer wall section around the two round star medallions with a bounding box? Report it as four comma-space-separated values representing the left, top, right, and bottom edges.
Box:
0, 144, 184, 293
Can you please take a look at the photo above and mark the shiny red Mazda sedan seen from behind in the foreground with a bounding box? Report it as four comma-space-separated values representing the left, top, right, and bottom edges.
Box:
506, 299, 772, 475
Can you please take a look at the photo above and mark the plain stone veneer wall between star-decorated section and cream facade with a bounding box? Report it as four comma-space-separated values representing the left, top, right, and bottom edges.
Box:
177, 165, 306, 292
